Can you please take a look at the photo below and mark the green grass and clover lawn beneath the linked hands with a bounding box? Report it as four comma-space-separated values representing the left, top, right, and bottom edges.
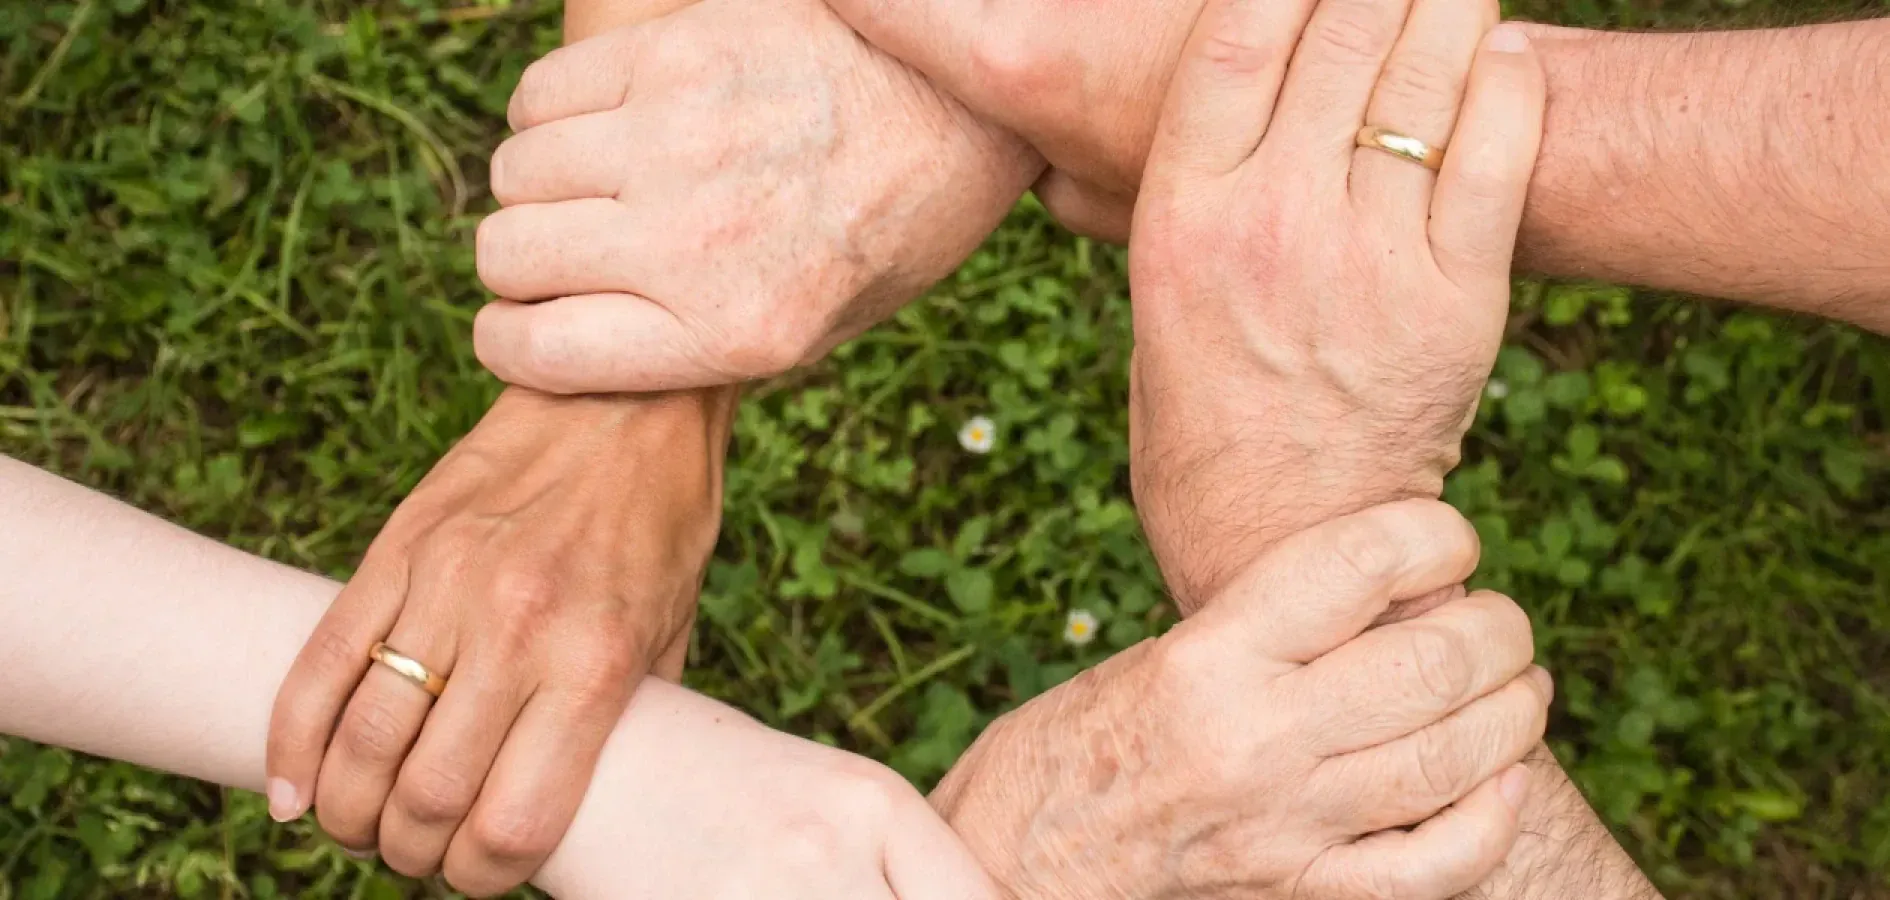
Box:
0, 0, 1890, 898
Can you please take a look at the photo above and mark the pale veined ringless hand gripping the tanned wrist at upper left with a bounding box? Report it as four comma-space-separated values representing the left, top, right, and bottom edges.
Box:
474, 0, 1036, 391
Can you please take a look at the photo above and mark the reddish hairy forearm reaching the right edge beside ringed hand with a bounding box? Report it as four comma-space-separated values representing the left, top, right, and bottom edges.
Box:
1520, 19, 1890, 331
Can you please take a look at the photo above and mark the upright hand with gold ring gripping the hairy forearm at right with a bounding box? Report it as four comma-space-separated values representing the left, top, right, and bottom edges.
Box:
1128, 0, 1544, 609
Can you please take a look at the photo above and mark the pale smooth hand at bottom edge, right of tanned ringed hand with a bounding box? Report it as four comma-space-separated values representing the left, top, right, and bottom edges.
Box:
533, 683, 996, 900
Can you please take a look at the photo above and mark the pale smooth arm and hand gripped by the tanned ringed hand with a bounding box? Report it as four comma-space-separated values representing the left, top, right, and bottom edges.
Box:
0, 458, 997, 900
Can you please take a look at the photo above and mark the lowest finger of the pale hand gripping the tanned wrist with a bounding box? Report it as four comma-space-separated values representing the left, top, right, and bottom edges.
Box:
473, 293, 729, 393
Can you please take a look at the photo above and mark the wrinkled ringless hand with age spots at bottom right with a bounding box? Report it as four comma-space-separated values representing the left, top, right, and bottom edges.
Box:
934, 501, 1552, 900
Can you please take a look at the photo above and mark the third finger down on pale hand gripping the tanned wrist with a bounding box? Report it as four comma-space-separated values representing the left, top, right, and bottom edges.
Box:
474, 197, 652, 301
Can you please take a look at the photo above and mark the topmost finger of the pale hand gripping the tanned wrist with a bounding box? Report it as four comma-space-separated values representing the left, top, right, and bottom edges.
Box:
505, 19, 662, 130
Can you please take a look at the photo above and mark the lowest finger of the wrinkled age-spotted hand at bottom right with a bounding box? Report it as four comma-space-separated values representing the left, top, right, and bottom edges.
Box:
1304, 766, 1529, 900
